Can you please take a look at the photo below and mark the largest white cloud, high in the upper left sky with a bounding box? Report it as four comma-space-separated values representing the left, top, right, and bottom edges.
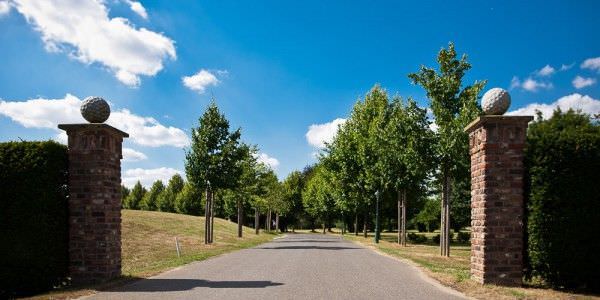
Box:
14, 0, 176, 86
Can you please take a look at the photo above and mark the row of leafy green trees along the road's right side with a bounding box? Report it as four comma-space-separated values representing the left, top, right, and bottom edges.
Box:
284, 44, 485, 256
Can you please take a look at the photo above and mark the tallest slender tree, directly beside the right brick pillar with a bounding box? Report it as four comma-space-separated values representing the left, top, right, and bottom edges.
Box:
408, 43, 486, 256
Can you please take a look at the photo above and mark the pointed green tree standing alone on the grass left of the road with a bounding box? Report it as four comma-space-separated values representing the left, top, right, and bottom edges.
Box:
185, 102, 244, 244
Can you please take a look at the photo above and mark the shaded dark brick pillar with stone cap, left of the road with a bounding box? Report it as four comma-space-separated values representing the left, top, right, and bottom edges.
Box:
58, 123, 129, 283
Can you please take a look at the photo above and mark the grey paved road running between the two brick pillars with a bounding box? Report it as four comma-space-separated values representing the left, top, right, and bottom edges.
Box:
90, 234, 462, 300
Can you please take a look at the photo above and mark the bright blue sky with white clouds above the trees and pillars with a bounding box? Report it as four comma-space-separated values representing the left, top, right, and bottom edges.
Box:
0, 0, 600, 184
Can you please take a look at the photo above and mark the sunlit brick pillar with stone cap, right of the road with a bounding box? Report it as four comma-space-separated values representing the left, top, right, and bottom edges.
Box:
465, 115, 533, 286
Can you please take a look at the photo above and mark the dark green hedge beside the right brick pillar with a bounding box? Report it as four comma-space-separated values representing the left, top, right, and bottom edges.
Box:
525, 111, 600, 290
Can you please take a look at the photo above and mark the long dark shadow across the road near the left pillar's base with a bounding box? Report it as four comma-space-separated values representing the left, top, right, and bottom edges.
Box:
110, 278, 283, 292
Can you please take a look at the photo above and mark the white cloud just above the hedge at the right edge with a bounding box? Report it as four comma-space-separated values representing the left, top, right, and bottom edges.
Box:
506, 93, 600, 119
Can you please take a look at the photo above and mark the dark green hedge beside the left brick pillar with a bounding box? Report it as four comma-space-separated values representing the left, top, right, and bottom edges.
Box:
0, 141, 68, 298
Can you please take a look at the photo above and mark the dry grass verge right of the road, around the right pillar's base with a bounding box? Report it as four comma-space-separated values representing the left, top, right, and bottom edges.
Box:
345, 233, 598, 299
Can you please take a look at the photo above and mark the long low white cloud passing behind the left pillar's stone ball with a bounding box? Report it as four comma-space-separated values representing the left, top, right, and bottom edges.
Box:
0, 94, 189, 147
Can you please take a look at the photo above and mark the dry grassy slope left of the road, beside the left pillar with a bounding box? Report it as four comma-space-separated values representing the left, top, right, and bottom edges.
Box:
33, 210, 274, 299
